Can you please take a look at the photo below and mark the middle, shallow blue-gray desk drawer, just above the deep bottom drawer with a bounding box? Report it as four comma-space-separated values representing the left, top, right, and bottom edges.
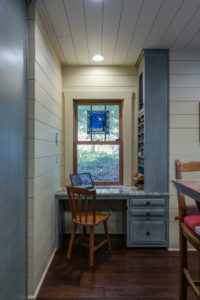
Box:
129, 207, 166, 218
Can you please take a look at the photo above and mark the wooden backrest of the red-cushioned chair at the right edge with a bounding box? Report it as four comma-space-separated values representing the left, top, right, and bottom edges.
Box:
175, 159, 200, 218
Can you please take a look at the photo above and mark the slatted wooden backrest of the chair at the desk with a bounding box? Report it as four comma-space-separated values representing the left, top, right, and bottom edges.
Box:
67, 186, 96, 224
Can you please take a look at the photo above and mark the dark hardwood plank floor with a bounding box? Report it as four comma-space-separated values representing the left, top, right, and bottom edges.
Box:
37, 236, 199, 300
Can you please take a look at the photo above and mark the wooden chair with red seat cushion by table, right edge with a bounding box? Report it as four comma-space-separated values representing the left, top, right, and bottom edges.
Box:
175, 160, 200, 300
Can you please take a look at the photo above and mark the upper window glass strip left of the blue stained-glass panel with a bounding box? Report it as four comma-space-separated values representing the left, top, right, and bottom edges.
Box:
78, 105, 90, 141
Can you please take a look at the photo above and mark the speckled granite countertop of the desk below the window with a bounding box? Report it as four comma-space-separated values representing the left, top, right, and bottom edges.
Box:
55, 185, 169, 199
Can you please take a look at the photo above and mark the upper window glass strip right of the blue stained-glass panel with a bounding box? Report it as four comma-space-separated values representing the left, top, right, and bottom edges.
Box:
106, 105, 119, 141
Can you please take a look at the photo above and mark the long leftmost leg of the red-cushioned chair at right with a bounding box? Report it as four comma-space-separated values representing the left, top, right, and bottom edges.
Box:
179, 223, 187, 300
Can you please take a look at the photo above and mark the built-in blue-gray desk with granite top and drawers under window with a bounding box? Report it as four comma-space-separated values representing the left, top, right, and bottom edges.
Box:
55, 186, 168, 248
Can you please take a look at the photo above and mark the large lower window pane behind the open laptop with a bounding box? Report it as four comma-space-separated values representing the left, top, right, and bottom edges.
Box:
77, 145, 119, 181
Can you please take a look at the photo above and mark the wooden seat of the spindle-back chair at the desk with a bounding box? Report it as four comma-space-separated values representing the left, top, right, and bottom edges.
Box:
72, 212, 109, 226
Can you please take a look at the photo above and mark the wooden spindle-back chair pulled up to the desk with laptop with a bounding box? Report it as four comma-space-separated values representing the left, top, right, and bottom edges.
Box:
67, 186, 111, 266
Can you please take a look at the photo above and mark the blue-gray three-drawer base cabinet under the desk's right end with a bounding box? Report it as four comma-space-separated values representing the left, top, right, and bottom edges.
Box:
127, 196, 168, 247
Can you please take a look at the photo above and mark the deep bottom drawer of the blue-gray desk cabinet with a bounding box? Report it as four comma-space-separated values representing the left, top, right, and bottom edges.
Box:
129, 220, 166, 244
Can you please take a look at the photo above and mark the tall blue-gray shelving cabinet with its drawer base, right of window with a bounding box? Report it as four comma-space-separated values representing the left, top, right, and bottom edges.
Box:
127, 49, 169, 247
